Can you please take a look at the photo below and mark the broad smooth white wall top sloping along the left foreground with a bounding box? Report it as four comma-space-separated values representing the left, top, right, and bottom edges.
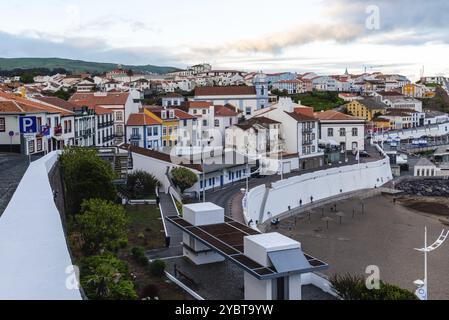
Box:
0, 152, 82, 300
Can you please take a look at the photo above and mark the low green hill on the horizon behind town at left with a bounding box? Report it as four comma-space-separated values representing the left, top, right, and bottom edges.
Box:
0, 58, 179, 74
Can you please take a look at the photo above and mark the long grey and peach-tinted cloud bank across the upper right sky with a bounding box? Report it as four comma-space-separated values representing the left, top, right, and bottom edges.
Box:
193, 0, 449, 56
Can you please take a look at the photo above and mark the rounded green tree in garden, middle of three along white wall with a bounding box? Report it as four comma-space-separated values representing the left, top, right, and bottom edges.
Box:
75, 199, 129, 254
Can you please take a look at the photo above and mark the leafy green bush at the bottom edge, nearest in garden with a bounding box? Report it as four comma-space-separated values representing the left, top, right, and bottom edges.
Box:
80, 253, 138, 300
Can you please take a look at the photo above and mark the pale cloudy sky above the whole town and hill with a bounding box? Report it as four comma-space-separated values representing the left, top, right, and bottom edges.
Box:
0, 0, 449, 79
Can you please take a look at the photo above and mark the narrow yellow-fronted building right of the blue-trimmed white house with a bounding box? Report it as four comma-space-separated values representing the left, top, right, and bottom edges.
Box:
144, 108, 179, 147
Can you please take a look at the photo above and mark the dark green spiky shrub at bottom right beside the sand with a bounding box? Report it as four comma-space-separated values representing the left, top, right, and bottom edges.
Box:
330, 274, 417, 300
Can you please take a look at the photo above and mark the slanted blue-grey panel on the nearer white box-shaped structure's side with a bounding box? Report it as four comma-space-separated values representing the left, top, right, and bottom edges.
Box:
268, 248, 312, 273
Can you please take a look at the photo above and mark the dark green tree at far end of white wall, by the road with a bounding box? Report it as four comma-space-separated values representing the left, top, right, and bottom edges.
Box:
59, 147, 117, 214
